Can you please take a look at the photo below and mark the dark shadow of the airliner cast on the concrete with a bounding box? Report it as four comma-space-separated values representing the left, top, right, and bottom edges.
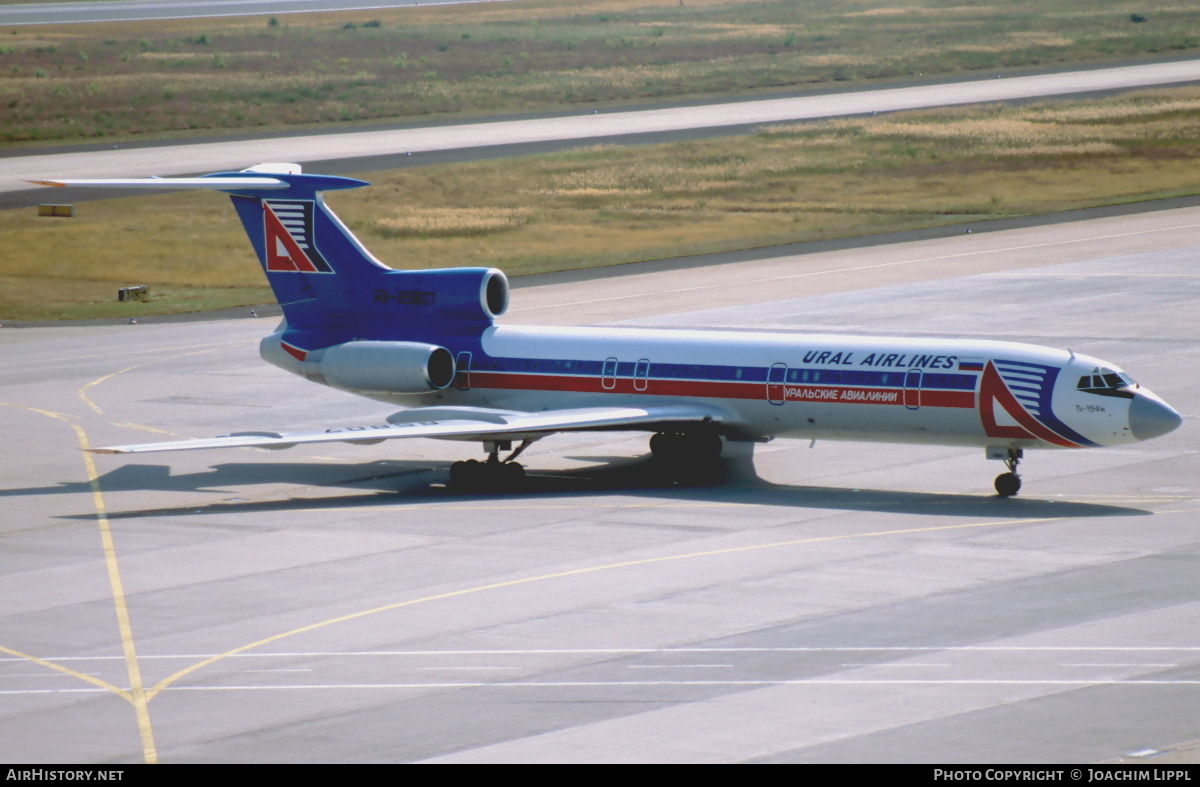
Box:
9, 456, 1152, 519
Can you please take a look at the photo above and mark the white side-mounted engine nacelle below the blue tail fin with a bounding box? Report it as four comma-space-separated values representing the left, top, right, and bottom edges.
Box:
301, 342, 455, 394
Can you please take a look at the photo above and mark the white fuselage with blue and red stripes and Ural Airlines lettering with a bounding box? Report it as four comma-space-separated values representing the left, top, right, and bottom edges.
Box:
263, 326, 1178, 449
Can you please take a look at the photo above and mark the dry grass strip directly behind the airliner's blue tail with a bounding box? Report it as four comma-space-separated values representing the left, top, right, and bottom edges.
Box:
0, 86, 1200, 319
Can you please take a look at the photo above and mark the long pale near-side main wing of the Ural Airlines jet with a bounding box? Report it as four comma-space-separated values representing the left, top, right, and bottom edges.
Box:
88, 404, 721, 453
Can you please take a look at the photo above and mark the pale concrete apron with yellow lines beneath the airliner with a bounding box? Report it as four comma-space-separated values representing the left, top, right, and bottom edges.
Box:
0, 202, 1200, 765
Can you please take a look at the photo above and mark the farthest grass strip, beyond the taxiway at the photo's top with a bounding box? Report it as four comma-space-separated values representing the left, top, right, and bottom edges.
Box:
0, 0, 1200, 145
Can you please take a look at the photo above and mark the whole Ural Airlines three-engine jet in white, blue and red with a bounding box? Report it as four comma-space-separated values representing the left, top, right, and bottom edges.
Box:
38, 164, 1181, 497
